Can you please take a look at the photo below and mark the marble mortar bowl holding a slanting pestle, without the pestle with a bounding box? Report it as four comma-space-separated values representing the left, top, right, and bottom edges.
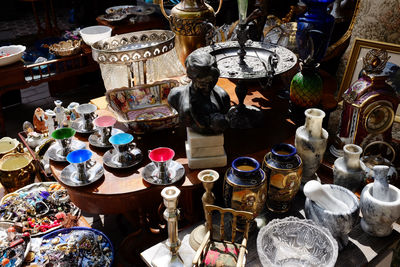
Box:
304, 185, 360, 250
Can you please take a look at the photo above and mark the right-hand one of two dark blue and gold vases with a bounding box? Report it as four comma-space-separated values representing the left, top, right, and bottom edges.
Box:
262, 144, 303, 213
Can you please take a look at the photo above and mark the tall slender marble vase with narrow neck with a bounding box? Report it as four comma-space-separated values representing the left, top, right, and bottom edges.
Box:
294, 108, 328, 184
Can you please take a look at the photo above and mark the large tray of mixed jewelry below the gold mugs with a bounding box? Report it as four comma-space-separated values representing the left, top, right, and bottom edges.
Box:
0, 182, 81, 237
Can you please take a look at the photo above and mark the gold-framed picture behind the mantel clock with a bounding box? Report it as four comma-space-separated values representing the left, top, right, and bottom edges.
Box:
338, 38, 400, 122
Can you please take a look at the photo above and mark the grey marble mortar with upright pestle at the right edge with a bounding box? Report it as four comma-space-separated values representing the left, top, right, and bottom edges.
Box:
360, 165, 400, 237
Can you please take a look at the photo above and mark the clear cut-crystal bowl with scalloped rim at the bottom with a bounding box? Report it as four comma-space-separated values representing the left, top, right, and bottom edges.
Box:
257, 217, 338, 267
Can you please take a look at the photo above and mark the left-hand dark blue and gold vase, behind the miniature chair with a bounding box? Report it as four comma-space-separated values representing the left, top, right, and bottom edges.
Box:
224, 157, 267, 217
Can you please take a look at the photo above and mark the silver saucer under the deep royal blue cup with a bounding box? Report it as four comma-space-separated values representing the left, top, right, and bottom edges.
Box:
60, 161, 104, 187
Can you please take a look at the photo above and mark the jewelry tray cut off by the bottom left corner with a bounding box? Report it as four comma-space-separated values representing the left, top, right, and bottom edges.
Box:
0, 222, 31, 267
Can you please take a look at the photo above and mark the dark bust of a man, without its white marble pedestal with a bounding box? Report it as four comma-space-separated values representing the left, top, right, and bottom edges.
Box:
168, 53, 230, 134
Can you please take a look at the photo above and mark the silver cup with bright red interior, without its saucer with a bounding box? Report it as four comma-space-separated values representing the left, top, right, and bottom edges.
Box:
149, 147, 175, 182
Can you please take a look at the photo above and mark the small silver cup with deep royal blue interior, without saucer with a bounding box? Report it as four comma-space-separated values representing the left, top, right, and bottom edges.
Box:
67, 149, 96, 181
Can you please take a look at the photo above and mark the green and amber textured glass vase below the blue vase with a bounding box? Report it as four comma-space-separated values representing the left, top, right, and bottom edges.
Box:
290, 66, 323, 108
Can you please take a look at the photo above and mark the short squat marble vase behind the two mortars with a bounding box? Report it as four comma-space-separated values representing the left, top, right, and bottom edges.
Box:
333, 144, 365, 192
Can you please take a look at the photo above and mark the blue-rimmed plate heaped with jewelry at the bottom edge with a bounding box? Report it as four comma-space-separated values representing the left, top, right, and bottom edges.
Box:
33, 227, 114, 267
